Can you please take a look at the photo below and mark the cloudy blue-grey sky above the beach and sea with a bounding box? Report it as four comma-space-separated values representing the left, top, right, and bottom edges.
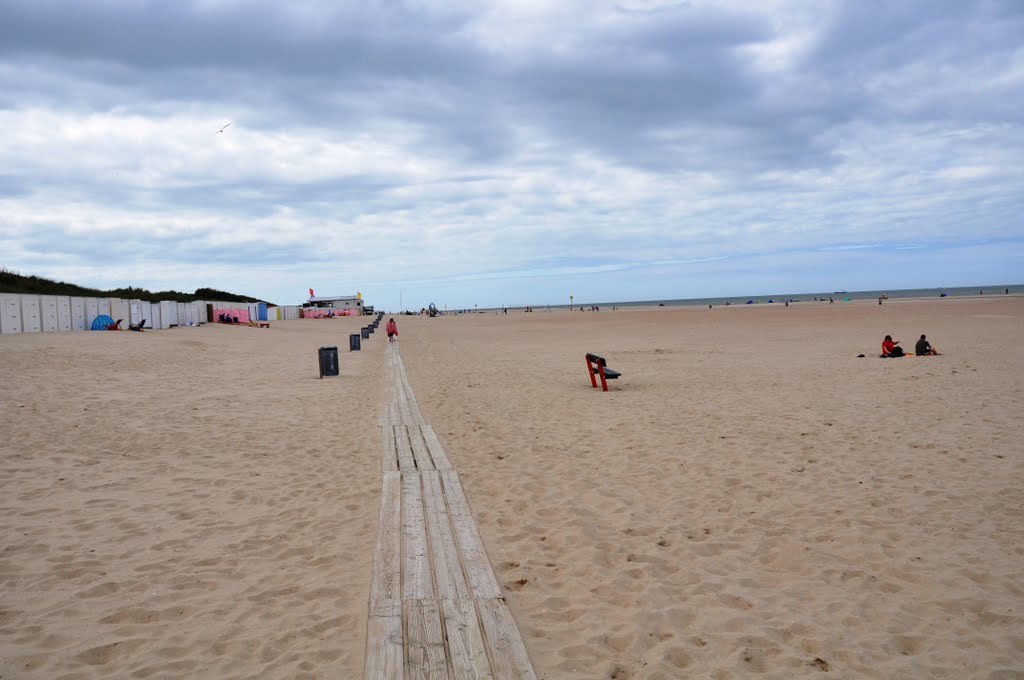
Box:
0, 0, 1024, 310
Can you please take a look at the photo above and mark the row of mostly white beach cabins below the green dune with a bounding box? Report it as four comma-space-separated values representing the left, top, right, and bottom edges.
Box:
0, 293, 302, 334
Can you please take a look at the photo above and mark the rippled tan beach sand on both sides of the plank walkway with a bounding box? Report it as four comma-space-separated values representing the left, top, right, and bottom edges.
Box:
0, 296, 1024, 680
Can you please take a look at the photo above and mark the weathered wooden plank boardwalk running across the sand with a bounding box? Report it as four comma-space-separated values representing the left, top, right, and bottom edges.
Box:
364, 343, 537, 680
